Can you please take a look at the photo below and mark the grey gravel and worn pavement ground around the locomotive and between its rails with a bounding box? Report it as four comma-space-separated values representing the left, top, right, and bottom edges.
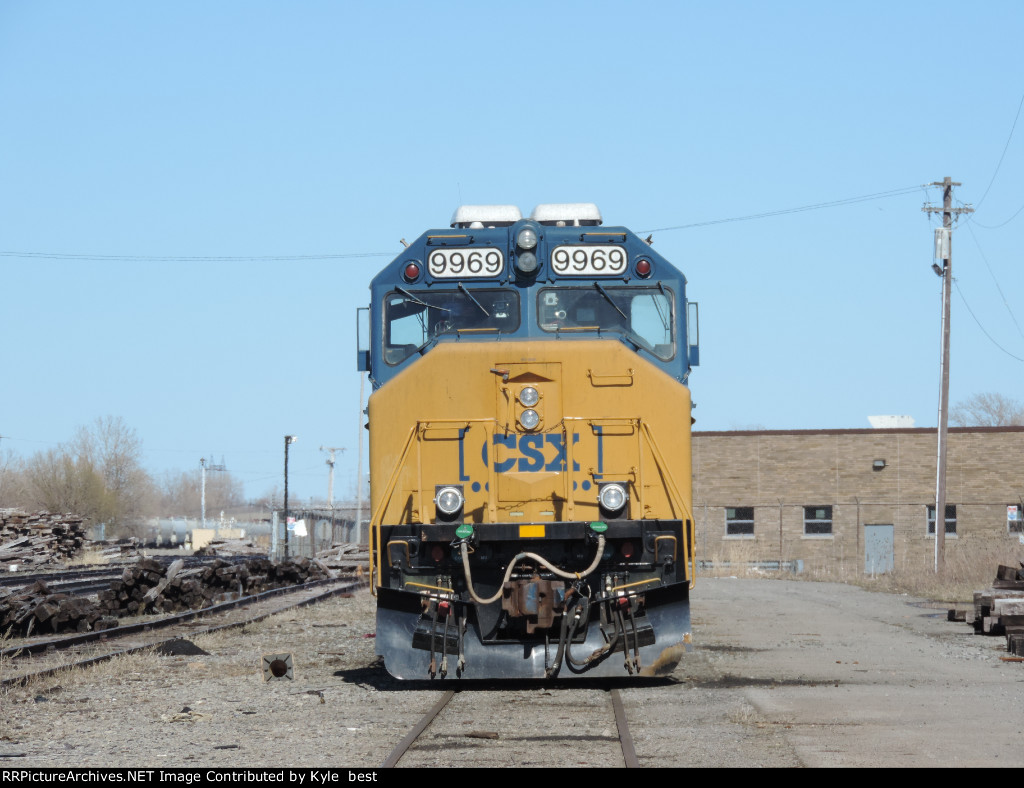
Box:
0, 578, 1024, 769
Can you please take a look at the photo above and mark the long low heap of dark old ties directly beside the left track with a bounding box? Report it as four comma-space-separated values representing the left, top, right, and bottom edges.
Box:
0, 558, 333, 638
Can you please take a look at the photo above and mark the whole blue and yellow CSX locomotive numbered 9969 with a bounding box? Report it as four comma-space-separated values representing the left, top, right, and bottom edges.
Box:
358, 204, 698, 681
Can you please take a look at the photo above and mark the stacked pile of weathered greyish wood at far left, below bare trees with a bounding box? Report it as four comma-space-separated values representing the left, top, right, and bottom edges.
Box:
0, 509, 87, 564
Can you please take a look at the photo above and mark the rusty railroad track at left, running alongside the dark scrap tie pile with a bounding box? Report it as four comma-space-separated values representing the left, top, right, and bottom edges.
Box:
0, 578, 364, 687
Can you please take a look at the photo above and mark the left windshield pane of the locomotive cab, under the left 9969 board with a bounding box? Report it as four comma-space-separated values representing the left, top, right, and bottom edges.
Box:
384, 284, 519, 364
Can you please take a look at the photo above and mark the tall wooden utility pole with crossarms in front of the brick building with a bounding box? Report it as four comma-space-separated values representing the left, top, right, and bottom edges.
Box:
921, 176, 974, 574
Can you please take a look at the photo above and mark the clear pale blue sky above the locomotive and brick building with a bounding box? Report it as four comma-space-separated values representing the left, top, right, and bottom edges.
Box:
0, 0, 1024, 497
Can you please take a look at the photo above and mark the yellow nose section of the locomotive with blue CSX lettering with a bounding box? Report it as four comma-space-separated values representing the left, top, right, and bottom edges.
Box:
369, 341, 692, 540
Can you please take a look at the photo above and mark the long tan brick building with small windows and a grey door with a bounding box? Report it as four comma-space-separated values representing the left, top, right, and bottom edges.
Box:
693, 427, 1024, 572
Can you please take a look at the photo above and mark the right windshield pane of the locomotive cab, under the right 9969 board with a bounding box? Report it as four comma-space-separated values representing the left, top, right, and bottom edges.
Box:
537, 282, 676, 361
